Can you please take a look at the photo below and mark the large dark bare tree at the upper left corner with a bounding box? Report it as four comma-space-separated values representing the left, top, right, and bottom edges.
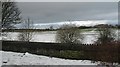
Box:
2, 0, 21, 29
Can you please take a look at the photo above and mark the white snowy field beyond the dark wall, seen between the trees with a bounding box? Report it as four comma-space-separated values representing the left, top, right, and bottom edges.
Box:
2, 29, 118, 44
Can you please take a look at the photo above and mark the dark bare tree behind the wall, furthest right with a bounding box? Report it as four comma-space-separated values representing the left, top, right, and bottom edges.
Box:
96, 25, 115, 44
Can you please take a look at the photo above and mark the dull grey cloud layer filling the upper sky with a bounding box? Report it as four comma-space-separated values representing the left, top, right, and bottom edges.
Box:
18, 2, 118, 23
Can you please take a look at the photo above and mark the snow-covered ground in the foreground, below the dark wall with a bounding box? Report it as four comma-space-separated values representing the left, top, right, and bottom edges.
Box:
0, 51, 97, 65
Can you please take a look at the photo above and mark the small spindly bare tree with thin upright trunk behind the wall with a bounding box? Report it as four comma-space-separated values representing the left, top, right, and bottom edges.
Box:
18, 18, 34, 41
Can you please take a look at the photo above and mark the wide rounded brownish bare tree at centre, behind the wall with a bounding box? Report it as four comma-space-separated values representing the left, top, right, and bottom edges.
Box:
56, 24, 83, 44
